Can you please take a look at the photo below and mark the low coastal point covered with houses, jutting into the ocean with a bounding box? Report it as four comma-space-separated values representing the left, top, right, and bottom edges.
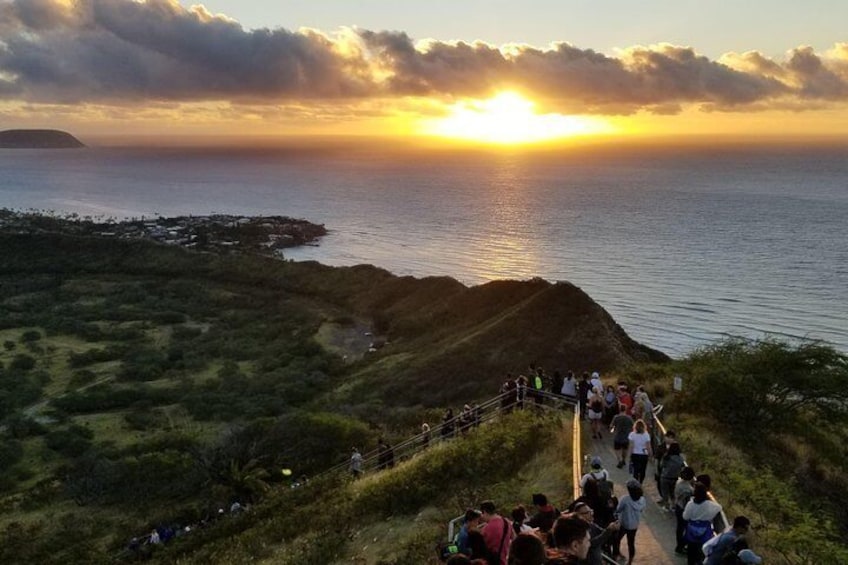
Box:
0, 209, 327, 254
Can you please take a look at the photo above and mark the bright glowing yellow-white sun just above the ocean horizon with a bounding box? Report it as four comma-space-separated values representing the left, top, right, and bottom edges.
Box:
421, 92, 613, 145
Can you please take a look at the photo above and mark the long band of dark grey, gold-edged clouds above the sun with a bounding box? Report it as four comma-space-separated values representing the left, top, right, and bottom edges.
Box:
0, 0, 848, 114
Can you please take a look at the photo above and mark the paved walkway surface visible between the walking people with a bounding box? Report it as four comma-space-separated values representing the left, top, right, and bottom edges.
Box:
581, 430, 686, 565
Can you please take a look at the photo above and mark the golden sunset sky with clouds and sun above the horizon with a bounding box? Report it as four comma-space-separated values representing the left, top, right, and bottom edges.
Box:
0, 0, 848, 143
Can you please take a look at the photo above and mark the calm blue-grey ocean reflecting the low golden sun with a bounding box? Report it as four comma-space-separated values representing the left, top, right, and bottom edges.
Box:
0, 146, 848, 356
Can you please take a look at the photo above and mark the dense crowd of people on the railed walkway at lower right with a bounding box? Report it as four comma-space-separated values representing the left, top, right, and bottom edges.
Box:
440, 365, 762, 565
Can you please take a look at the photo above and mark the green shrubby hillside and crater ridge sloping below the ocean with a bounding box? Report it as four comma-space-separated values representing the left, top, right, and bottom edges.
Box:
0, 233, 848, 564
